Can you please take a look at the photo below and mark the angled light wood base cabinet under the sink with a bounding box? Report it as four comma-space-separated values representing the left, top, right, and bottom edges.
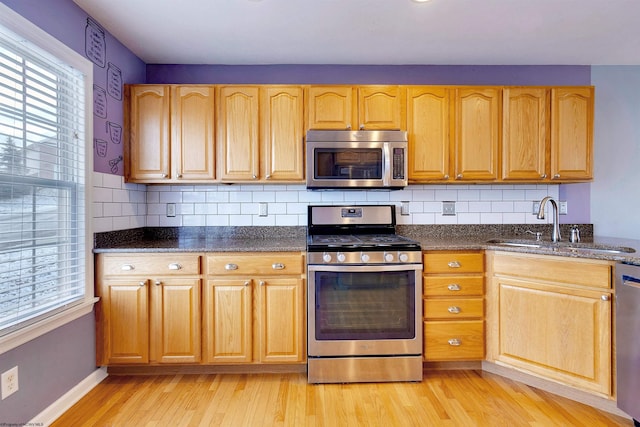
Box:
487, 252, 613, 397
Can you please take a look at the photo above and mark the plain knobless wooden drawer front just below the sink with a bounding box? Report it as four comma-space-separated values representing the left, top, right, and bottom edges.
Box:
493, 252, 612, 289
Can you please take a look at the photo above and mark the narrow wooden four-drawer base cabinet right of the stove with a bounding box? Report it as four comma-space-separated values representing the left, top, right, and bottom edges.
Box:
423, 251, 484, 362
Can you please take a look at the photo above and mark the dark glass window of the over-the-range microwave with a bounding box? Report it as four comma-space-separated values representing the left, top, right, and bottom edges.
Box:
314, 148, 382, 179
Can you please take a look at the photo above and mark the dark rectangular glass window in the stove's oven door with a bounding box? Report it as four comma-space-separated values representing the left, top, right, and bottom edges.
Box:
315, 271, 416, 340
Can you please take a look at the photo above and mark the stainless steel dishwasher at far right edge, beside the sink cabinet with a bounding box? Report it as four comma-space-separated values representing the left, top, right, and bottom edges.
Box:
616, 263, 640, 427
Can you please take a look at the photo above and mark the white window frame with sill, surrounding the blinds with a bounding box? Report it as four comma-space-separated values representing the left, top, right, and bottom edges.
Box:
0, 3, 98, 354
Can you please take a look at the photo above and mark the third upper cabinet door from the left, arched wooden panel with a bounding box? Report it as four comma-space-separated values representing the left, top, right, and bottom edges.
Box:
217, 86, 259, 181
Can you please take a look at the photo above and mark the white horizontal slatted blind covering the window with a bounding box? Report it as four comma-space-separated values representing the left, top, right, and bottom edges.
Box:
0, 20, 90, 336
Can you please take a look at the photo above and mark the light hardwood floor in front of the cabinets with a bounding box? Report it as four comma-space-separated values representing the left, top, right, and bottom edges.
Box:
53, 370, 633, 427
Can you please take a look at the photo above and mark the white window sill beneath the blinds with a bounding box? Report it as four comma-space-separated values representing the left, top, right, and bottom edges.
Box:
0, 298, 99, 354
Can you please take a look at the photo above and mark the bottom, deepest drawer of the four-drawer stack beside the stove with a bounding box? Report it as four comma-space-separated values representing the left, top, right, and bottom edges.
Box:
424, 320, 484, 360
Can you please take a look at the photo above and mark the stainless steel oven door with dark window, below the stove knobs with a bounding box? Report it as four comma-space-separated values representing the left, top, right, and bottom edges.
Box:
307, 264, 422, 357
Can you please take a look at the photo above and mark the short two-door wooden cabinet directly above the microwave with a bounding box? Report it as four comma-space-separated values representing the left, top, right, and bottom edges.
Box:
307, 86, 404, 130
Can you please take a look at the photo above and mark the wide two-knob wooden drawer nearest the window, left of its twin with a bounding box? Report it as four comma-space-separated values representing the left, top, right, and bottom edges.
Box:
102, 254, 202, 277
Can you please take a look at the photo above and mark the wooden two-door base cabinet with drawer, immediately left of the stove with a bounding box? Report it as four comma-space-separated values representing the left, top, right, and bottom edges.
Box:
203, 252, 306, 363
